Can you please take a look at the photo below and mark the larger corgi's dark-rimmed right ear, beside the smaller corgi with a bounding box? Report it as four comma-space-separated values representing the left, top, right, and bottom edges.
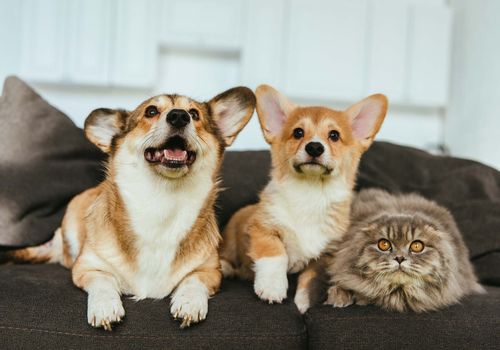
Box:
208, 86, 255, 146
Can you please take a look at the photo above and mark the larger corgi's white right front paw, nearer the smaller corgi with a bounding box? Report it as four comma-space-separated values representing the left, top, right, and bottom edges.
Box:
170, 279, 208, 328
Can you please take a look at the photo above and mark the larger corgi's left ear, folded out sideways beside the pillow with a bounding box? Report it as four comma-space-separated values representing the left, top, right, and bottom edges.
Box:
84, 108, 128, 153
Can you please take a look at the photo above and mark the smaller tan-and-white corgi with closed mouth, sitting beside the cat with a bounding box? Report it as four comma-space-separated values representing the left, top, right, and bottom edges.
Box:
220, 85, 387, 312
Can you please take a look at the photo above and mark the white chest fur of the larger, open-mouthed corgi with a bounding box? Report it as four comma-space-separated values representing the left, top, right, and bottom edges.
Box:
116, 150, 213, 299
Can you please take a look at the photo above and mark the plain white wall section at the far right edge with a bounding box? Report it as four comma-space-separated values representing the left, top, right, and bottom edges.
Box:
445, 0, 500, 169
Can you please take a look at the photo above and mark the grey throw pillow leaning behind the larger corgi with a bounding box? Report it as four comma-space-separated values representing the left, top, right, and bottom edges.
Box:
0, 77, 104, 247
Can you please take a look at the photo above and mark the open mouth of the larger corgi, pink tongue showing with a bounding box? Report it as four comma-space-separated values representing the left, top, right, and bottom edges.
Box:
144, 136, 196, 168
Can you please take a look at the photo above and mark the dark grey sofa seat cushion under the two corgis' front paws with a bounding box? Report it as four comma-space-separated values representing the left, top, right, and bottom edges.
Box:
0, 265, 307, 350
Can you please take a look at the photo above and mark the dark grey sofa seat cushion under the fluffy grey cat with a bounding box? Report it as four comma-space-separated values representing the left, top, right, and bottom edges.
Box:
305, 287, 500, 350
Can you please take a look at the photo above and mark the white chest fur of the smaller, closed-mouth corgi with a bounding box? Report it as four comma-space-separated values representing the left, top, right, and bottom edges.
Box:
265, 178, 351, 272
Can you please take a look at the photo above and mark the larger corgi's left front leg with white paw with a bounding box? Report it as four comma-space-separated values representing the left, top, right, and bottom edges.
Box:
73, 263, 125, 331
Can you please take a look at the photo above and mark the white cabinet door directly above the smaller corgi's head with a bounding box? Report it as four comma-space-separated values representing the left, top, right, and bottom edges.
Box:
284, 0, 367, 100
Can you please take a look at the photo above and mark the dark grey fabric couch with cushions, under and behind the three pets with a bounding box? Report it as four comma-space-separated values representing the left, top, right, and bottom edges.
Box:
0, 78, 500, 349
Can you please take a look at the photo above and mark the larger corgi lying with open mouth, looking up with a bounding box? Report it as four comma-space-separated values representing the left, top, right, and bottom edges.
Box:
1, 87, 255, 330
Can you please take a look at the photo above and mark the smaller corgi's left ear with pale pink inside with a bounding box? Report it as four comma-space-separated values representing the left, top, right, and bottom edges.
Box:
255, 85, 295, 144
